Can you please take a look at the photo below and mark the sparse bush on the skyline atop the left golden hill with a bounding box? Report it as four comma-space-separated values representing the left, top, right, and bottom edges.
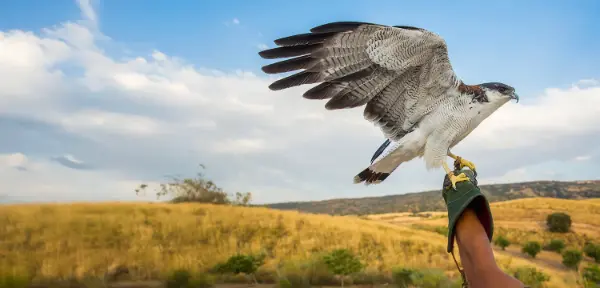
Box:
135, 164, 252, 206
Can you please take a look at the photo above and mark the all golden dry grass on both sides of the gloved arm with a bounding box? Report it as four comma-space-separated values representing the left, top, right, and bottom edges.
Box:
0, 199, 600, 287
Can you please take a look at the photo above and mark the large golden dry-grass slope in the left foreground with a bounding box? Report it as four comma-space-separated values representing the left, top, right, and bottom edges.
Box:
0, 203, 454, 279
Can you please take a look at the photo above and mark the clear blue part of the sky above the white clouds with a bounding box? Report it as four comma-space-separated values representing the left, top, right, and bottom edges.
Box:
0, 0, 600, 94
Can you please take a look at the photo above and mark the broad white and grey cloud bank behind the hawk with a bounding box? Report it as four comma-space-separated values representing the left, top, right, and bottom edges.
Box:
0, 1, 600, 202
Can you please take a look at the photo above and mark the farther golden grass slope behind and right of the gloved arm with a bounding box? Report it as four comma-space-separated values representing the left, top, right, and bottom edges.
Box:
367, 198, 600, 287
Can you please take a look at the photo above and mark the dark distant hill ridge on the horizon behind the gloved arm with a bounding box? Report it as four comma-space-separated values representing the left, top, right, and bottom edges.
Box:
265, 180, 600, 215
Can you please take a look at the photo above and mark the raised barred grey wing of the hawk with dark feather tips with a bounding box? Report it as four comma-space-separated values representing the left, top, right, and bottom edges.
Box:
259, 22, 462, 140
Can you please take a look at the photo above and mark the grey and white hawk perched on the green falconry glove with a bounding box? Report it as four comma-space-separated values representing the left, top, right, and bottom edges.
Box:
259, 22, 519, 187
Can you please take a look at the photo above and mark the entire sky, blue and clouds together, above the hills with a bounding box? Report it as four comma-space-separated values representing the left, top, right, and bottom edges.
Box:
0, 0, 600, 203
